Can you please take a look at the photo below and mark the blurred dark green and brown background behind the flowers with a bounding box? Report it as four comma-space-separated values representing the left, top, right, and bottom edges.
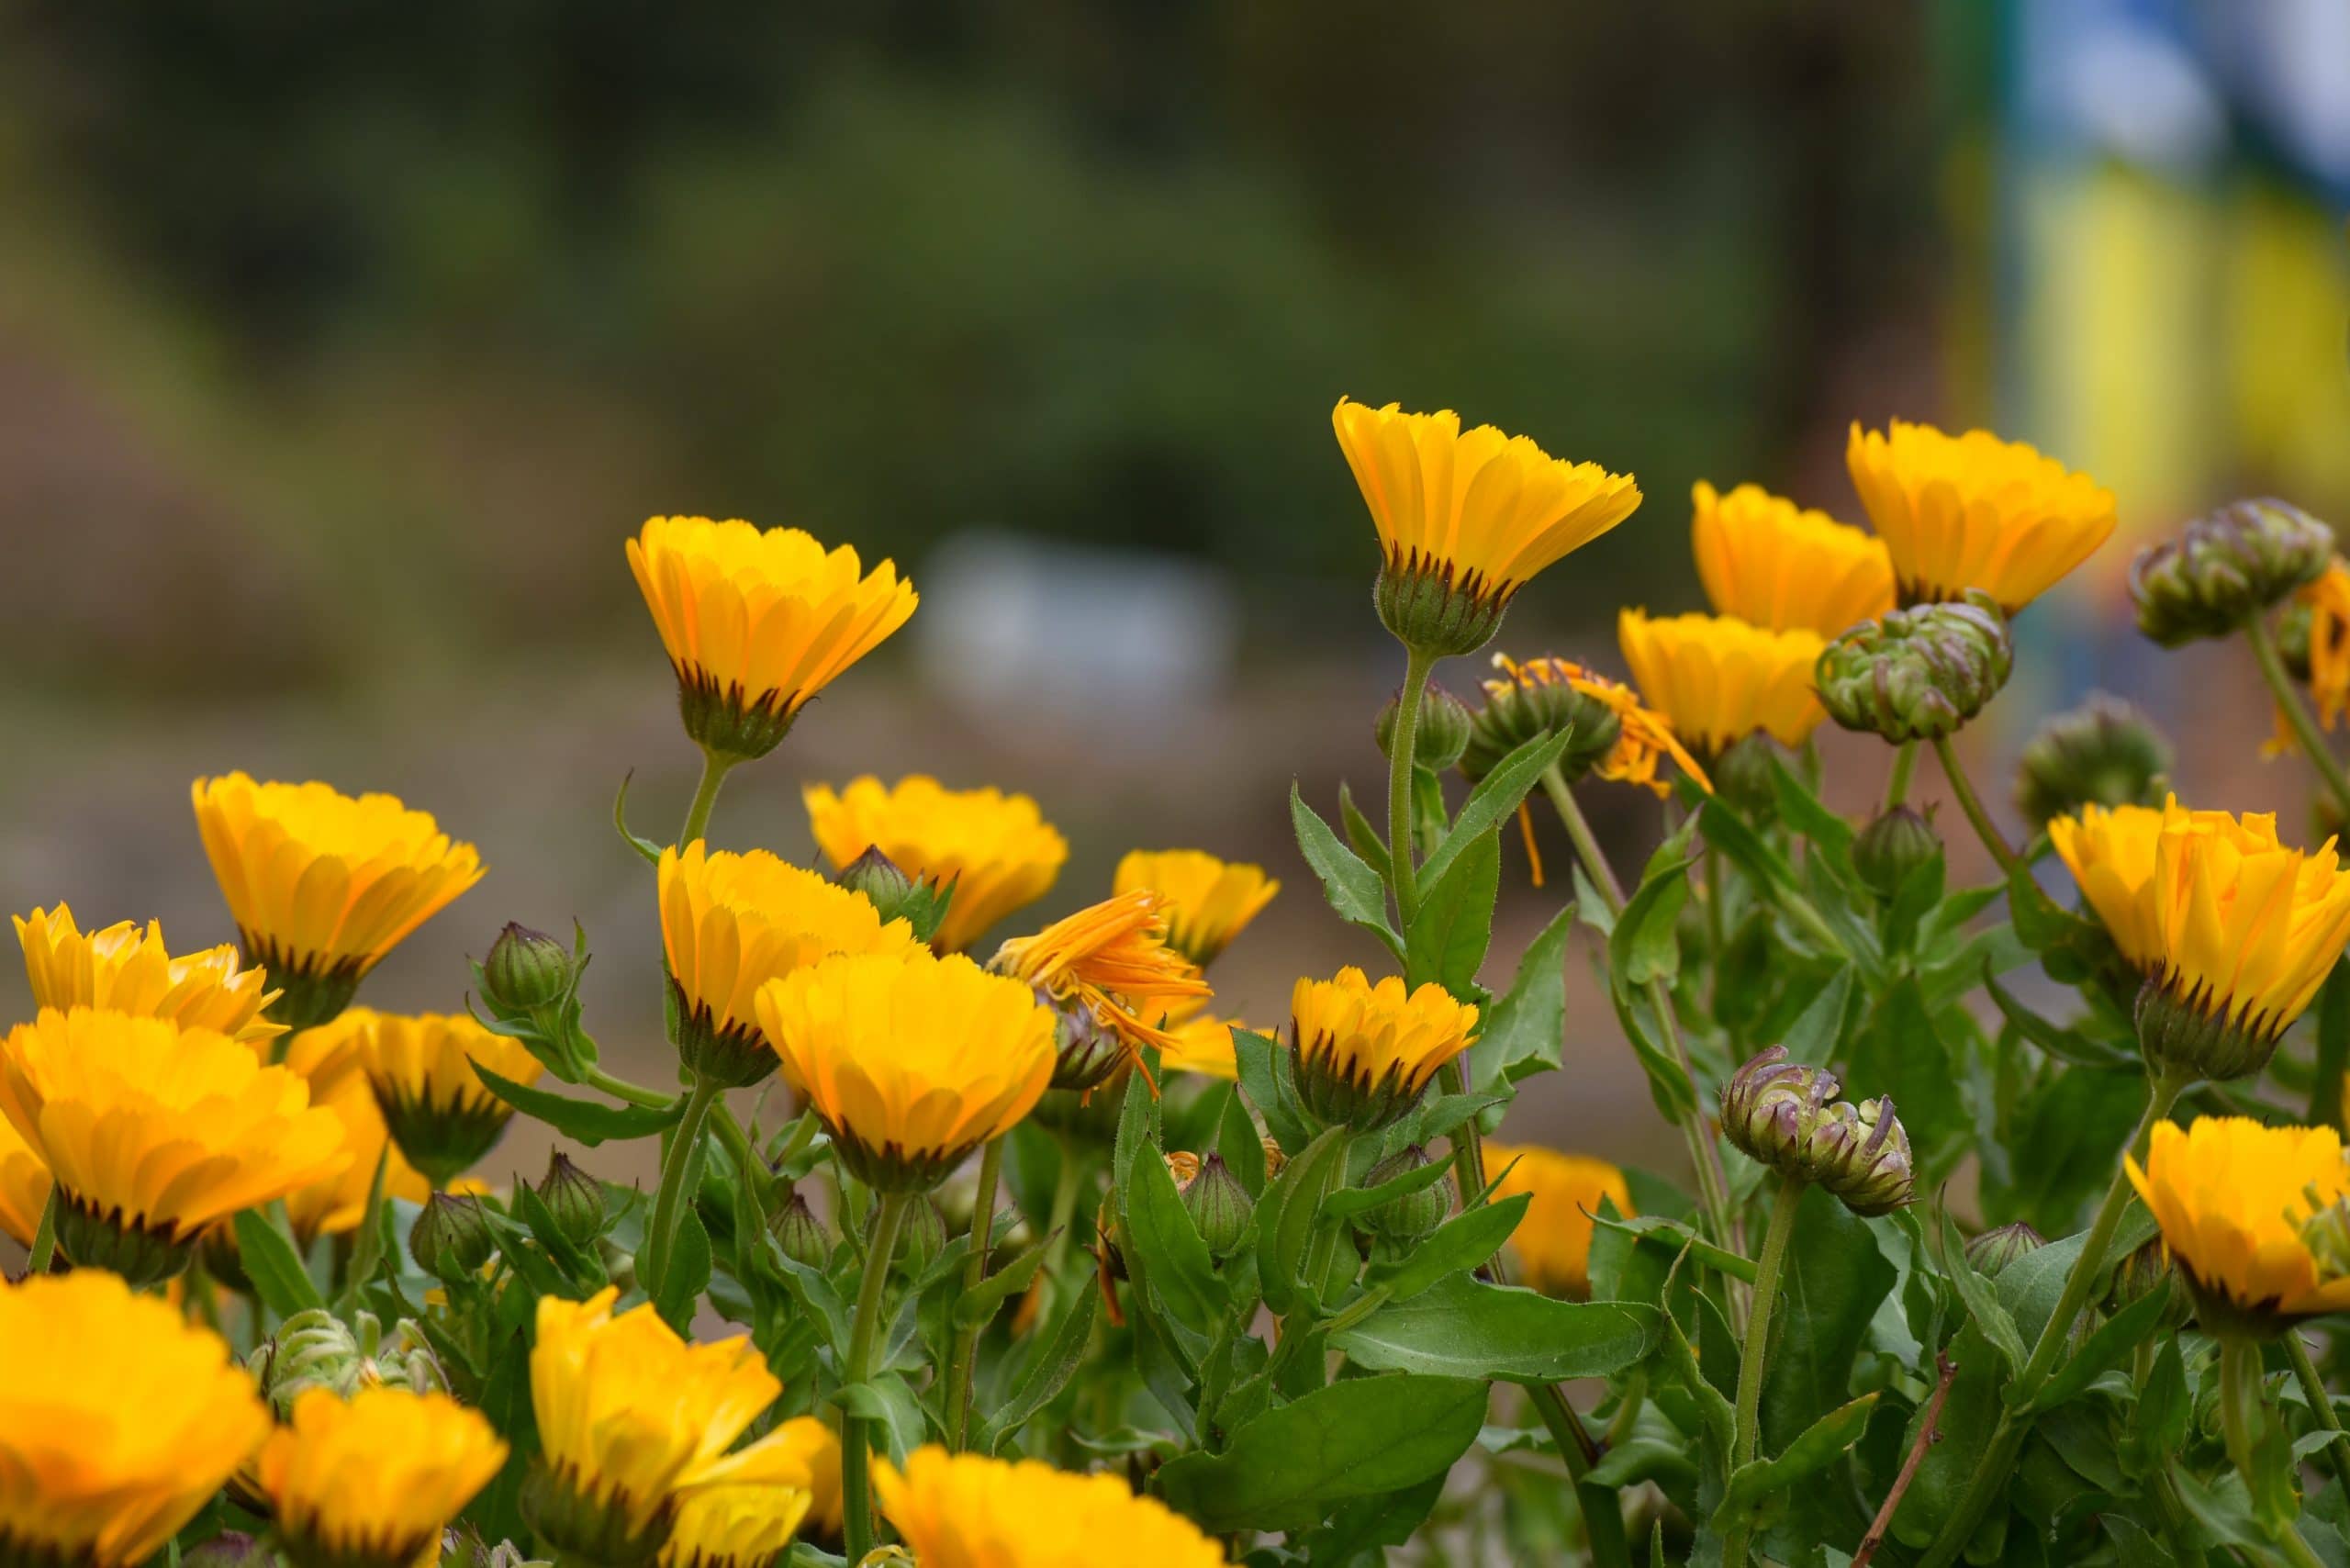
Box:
0, 0, 2350, 1193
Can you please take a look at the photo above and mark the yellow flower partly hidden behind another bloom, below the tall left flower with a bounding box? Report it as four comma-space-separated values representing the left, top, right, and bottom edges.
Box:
658, 839, 919, 1086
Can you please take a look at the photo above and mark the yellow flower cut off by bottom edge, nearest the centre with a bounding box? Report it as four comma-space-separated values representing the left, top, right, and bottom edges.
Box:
874, 1443, 1225, 1568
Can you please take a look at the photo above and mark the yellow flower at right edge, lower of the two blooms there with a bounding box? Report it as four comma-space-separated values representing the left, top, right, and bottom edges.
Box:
2124, 1116, 2350, 1328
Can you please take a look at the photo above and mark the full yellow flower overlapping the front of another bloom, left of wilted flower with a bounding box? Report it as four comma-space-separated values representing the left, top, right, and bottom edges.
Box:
759, 952, 1053, 1192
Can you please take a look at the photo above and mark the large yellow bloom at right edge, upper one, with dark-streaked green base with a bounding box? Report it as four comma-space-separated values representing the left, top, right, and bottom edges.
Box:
2049, 797, 2350, 1079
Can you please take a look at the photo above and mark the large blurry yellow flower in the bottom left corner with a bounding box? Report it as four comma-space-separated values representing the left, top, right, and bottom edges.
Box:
0, 1269, 270, 1568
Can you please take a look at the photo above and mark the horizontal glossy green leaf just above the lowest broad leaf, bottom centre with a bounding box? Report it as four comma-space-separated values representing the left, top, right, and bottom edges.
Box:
1330, 1274, 1659, 1383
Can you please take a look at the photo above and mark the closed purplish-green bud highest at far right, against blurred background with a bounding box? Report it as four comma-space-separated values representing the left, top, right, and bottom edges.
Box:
2129, 500, 2333, 649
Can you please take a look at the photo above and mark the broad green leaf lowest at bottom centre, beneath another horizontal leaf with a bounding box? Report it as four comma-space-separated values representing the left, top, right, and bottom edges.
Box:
1157, 1372, 1487, 1535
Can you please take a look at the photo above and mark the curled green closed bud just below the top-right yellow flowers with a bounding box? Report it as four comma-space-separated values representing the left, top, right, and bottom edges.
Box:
1812, 590, 2016, 743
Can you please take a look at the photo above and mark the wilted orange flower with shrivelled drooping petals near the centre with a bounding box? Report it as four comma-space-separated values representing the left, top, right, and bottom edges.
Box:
990, 889, 1210, 1089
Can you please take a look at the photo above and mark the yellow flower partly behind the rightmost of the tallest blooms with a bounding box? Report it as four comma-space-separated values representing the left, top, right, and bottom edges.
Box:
1690, 479, 1894, 637
